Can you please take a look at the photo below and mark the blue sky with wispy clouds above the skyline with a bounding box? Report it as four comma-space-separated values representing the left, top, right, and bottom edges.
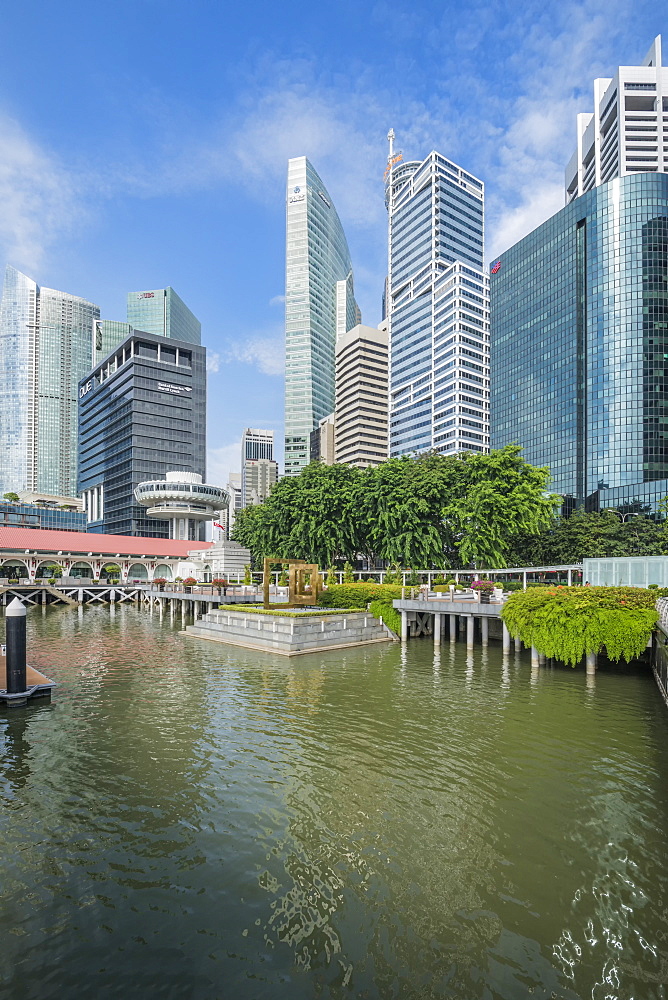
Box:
0, 0, 668, 482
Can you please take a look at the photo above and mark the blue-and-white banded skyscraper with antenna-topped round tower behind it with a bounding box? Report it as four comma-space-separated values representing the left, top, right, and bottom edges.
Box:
384, 131, 489, 457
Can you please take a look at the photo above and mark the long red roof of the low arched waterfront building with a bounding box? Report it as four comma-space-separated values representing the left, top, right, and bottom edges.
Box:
0, 527, 213, 559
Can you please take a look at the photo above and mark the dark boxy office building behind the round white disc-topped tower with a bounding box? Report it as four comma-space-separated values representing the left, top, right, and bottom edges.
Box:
79, 331, 206, 540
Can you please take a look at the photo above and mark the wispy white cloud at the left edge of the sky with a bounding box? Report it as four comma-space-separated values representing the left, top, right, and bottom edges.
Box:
0, 112, 84, 273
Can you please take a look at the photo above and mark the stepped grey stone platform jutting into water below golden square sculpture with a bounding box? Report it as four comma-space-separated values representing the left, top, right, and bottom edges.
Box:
182, 610, 395, 656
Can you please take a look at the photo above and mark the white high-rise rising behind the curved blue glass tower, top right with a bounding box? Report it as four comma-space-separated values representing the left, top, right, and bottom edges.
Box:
566, 35, 668, 204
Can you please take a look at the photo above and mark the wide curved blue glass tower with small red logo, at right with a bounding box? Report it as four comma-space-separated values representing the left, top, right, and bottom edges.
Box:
491, 173, 668, 509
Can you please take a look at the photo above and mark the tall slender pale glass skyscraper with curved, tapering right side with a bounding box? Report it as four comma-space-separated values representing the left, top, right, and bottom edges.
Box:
285, 156, 360, 475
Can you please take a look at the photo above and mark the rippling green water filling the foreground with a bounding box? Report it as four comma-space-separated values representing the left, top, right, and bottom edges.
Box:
0, 607, 668, 1000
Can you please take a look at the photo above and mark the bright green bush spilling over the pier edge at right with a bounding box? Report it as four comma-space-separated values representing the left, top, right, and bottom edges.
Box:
501, 586, 659, 666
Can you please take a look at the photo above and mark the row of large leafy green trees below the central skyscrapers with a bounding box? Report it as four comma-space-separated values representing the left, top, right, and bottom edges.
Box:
233, 445, 560, 569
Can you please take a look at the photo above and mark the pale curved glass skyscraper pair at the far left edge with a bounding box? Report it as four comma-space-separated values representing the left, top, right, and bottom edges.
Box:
0, 265, 100, 496
